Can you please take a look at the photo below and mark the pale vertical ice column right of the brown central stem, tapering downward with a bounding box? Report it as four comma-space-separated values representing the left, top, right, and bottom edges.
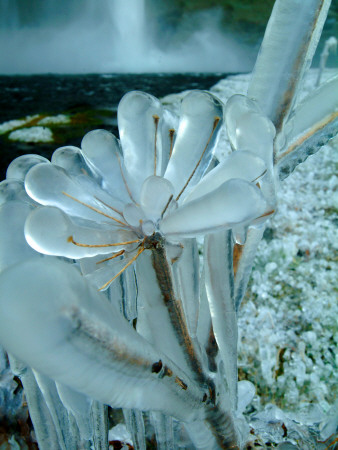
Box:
204, 231, 237, 409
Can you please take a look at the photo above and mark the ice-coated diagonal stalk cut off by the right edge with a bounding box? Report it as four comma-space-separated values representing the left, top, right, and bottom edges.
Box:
276, 76, 338, 179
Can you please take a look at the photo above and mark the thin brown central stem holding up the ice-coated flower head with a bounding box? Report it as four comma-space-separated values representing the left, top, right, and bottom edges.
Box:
146, 234, 239, 449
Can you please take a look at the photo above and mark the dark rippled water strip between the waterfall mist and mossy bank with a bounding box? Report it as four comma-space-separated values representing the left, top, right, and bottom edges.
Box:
0, 74, 226, 123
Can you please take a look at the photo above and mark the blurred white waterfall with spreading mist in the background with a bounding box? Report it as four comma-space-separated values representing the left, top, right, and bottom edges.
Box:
0, 0, 252, 74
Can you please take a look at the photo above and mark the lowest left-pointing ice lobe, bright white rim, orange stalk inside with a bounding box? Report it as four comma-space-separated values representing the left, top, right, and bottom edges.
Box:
25, 206, 137, 259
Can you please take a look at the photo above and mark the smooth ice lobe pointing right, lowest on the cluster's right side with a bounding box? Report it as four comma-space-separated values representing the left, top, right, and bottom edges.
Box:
160, 178, 267, 237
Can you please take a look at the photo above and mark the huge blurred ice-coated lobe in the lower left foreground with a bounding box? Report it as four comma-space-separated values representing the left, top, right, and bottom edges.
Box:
0, 258, 205, 421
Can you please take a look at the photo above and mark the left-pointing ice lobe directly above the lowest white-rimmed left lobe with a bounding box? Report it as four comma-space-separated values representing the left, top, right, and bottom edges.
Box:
25, 164, 121, 223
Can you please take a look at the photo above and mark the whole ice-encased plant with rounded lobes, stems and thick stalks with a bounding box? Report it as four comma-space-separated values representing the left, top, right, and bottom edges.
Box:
0, 0, 338, 450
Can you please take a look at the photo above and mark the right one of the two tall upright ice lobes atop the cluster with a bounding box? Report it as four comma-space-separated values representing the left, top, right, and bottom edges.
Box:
164, 91, 223, 198
